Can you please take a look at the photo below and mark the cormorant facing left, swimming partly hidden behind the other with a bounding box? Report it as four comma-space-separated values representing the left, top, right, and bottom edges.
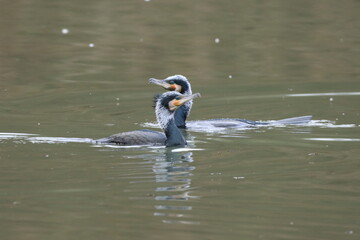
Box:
148, 75, 312, 129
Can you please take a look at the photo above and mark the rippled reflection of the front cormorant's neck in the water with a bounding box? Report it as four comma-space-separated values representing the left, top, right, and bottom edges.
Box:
128, 148, 199, 224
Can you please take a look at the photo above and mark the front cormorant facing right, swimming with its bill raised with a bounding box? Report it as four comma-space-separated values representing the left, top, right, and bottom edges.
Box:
96, 91, 200, 147
